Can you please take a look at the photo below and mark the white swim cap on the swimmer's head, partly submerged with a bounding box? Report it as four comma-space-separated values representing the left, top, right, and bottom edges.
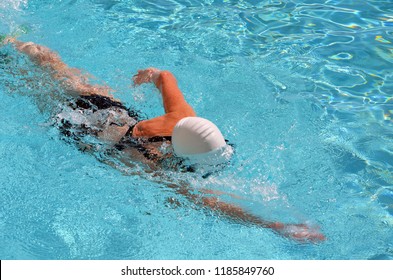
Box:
172, 117, 233, 165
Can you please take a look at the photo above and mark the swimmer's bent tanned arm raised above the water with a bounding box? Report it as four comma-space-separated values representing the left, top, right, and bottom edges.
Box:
132, 68, 196, 137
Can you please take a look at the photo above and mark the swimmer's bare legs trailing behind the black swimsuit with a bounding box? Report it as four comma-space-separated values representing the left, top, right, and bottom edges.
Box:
6, 37, 109, 96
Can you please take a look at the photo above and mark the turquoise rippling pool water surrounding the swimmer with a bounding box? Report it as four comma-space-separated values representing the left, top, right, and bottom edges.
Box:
0, 0, 393, 259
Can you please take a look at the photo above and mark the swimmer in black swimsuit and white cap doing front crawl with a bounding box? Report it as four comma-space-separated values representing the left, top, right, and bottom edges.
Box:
5, 37, 325, 242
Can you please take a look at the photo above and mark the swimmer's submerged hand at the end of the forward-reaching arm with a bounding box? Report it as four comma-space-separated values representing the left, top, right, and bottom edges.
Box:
269, 223, 326, 243
